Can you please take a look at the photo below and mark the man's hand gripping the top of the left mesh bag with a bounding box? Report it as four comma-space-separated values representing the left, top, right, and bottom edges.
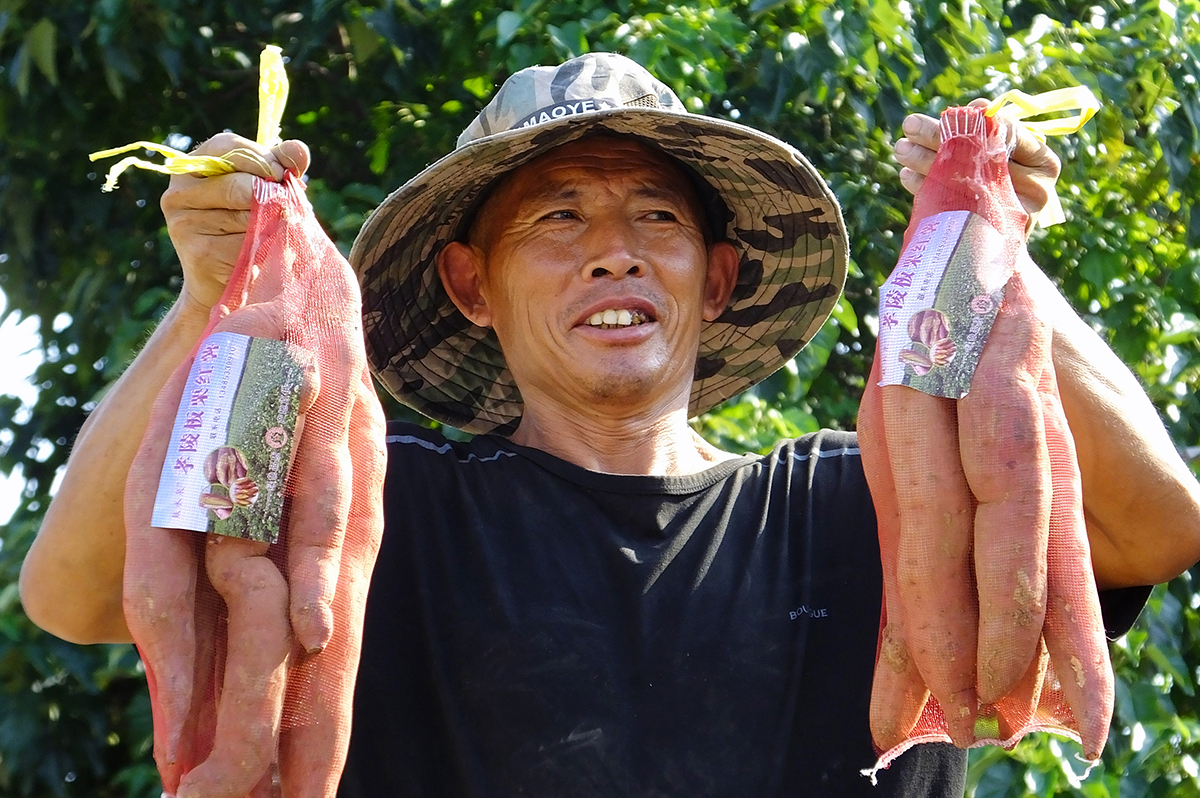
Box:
160, 133, 308, 314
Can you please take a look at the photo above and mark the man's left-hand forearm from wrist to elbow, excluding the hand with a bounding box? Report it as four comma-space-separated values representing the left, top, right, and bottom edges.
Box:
20, 293, 208, 643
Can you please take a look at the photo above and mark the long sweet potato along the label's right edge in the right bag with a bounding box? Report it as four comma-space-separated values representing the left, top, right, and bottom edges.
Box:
958, 274, 1051, 703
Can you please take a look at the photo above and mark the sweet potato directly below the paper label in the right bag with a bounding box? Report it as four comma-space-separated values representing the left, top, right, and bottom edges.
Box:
881, 385, 978, 748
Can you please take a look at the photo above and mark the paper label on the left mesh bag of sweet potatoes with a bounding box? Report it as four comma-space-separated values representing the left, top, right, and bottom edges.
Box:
152, 332, 304, 544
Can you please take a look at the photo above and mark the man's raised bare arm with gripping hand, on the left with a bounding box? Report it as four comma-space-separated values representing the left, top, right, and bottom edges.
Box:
20, 133, 308, 643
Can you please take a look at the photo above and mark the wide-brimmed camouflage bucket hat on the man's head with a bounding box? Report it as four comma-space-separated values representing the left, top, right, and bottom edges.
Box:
350, 53, 848, 433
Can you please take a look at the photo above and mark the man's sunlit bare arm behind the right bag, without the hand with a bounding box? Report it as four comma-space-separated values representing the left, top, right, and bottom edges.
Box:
1027, 258, 1200, 588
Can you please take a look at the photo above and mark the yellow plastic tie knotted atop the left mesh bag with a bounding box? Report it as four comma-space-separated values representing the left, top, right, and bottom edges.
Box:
88, 44, 288, 191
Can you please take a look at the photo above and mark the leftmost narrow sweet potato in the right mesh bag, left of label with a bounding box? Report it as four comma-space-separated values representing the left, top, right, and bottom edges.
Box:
858, 360, 929, 750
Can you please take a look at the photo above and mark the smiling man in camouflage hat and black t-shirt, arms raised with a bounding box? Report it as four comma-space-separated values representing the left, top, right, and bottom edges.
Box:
22, 54, 1200, 797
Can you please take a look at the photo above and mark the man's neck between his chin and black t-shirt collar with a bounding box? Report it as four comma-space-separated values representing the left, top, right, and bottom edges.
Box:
512, 404, 737, 475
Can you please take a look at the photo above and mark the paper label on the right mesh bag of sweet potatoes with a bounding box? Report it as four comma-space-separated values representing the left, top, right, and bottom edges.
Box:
878, 211, 1013, 398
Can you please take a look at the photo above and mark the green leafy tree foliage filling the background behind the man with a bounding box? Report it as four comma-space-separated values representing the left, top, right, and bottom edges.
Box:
0, 0, 1200, 798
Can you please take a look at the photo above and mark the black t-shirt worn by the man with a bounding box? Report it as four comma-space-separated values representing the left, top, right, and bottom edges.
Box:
338, 425, 1145, 798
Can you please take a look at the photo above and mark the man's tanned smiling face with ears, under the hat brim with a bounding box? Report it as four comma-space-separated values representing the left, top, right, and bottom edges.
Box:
443, 137, 737, 420
